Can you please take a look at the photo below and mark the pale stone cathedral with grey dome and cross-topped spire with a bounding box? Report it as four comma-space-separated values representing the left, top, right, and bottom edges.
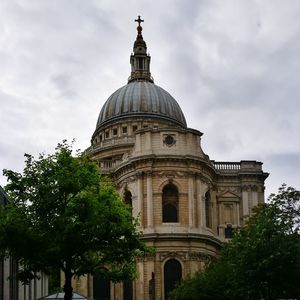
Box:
73, 17, 268, 300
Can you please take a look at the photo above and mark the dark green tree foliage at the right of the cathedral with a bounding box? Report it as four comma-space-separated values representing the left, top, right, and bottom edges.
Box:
170, 185, 300, 300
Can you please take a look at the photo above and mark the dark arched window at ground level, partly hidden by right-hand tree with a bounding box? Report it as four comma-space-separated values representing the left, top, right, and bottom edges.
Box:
164, 259, 182, 299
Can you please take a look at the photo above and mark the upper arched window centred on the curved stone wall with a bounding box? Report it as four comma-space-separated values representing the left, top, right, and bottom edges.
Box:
162, 183, 179, 223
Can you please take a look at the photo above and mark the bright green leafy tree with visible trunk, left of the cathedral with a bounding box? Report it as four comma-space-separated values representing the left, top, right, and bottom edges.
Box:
0, 141, 148, 300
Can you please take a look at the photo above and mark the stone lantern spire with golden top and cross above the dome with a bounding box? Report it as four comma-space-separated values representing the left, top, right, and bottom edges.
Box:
128, 16, 153, 83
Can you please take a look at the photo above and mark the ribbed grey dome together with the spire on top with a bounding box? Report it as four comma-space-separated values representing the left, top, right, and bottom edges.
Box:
96, 15, 187, 130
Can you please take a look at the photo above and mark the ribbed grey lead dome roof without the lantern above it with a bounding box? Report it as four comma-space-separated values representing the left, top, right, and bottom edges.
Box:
97, 81, 186, 128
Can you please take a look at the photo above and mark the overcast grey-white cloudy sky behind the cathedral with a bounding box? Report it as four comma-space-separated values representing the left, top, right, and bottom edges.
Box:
0, 0, 300, 195
